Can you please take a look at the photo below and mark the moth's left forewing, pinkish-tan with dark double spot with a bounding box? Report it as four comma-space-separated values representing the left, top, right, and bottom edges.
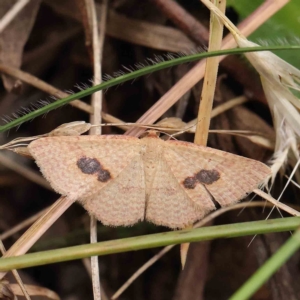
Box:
28, 135, 140, 200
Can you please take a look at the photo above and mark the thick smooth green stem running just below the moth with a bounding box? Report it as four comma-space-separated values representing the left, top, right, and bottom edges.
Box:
0, 217, 300, 271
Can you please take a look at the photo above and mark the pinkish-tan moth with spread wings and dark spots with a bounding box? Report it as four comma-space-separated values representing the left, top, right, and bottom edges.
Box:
28, 130, 271, 229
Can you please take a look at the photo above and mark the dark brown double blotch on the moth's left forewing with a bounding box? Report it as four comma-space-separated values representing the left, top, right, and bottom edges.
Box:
77, 157, 111, 182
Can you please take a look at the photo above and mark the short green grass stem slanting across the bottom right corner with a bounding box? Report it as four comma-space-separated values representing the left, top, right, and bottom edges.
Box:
230, 229, 300, 300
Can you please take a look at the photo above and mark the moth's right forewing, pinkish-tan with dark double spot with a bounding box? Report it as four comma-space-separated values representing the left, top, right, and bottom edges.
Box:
167, 141, 271, 206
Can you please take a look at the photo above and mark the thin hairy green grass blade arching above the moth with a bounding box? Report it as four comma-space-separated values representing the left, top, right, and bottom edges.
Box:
0, 45, 300, 132
